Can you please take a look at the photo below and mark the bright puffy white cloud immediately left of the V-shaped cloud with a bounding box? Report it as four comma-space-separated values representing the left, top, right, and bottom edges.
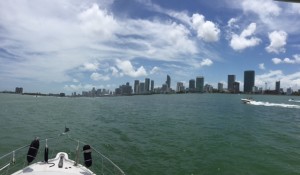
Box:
192, 13, 220, 42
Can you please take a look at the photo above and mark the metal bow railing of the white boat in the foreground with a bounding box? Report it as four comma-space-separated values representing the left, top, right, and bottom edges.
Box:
0, 133, 125, 175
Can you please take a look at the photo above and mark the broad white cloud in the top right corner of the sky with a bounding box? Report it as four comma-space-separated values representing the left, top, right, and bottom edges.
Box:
234, 0, 300, 34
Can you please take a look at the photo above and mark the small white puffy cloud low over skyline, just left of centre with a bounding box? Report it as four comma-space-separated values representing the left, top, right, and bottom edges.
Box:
116, 59, 147, 77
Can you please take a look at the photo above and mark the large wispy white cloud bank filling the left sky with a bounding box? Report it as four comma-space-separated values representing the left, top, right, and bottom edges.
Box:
0, 0, 204, 87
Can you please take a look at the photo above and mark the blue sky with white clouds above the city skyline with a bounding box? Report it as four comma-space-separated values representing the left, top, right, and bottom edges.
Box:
0, 0, 300, 94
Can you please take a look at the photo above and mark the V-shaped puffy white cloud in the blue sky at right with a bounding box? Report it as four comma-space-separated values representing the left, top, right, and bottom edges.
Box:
230, 23, 261, 51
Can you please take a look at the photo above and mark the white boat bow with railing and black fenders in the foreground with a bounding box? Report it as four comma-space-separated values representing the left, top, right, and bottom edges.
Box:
0, 128, 125, 175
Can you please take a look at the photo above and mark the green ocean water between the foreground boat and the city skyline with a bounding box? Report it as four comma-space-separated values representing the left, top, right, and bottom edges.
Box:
0, 94, 300, 175
